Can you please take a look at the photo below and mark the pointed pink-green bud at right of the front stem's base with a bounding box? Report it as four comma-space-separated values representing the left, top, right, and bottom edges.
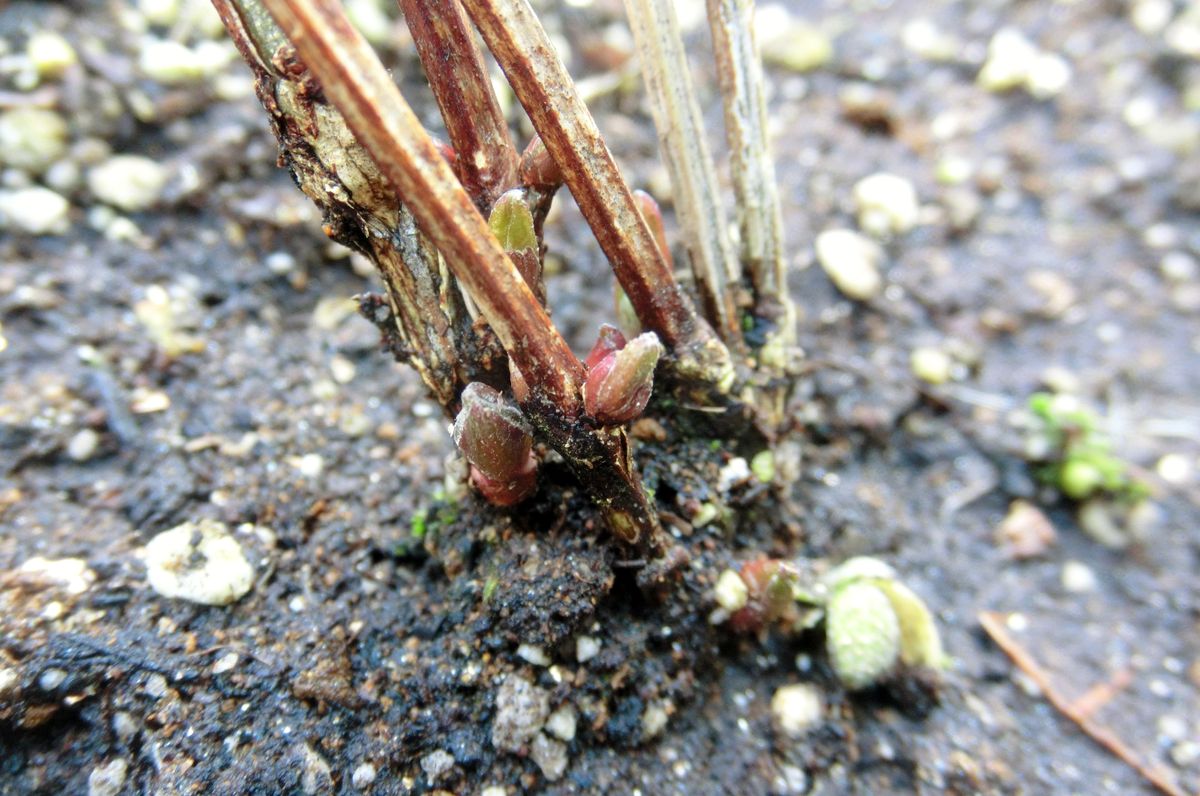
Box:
583, 331, 662, 425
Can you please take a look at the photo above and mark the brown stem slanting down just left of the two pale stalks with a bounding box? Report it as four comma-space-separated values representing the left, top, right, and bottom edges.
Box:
463, 0, 733, 388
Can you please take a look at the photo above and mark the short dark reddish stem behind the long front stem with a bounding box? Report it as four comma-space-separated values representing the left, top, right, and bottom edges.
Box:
398, 0, 517, 213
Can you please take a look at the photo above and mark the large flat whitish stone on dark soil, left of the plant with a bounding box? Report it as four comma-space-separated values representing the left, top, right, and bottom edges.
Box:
143, 520, 254, 605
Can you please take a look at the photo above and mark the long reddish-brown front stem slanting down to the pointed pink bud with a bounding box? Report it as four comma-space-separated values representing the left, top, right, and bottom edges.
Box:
262, 0, 583, 409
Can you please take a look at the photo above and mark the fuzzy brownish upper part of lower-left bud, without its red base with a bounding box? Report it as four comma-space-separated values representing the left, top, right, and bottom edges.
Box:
454, 382, 533, 483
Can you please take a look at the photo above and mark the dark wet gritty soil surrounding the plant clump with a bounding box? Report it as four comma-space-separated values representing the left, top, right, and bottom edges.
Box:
0, 1, 1200, 794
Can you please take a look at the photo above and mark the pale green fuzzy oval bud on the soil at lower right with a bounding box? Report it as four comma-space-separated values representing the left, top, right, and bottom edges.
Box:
826, 581, 900, 690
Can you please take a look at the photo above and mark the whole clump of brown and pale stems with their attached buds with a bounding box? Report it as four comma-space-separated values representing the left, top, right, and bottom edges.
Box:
212, 0, 792, 558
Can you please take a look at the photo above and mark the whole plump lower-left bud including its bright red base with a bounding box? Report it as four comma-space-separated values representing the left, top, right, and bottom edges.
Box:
454, 382, 538, 505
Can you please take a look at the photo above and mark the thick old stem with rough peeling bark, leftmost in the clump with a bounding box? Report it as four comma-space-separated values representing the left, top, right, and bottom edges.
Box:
214, 0, 496, 417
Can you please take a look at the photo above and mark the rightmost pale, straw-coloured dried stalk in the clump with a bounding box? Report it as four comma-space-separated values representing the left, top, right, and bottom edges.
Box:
708, 0, 796, 343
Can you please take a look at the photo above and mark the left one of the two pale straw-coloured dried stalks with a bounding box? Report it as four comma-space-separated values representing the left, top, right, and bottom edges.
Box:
625, 0, 742, 347
